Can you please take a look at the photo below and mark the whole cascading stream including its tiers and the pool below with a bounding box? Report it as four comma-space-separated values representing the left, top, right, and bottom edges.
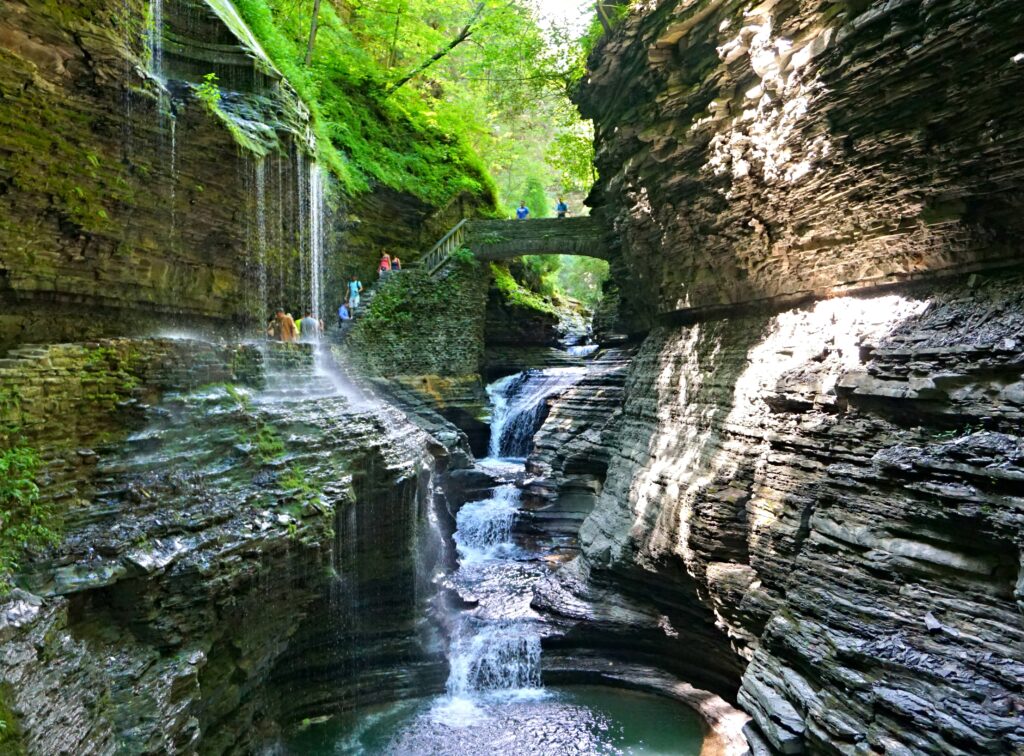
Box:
286, 368, 703, 756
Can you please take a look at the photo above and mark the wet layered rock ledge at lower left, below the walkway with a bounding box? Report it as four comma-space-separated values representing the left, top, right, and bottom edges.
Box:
0, 339, 457, 753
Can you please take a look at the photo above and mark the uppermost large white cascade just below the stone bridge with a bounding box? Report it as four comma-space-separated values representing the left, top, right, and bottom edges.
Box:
487, 368, 586, 458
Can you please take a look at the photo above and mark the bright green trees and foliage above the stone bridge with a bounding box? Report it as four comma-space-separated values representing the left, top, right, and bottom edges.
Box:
228, 0, 594, 215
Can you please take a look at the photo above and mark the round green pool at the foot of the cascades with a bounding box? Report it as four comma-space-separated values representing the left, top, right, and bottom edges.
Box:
285, 685, 703, 756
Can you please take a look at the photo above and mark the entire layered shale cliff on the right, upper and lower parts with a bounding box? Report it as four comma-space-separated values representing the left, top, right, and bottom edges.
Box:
532, 0, 1024, 754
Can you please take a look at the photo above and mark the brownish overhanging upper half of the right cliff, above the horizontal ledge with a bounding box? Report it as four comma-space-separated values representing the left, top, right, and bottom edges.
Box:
578, 0, 1024, 330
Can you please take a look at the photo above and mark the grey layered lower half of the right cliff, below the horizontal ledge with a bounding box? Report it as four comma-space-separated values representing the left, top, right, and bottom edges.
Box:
536, 277, 1024, 754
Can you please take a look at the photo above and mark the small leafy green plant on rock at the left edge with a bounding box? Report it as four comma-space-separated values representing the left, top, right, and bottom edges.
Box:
0, 445, 60, 595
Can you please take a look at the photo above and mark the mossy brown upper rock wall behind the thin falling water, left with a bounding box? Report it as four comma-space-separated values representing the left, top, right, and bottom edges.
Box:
0, 0, 481, 351
